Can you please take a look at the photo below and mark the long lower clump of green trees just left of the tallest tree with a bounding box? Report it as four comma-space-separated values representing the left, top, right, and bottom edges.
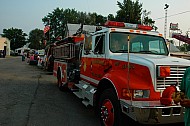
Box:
42, 8, 107, 44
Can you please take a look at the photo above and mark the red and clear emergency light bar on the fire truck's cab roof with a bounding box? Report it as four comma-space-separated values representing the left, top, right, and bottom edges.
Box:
105, 21, 153, 31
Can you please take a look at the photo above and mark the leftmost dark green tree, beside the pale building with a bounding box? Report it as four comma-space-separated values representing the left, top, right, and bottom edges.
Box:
2, 28, 27, 50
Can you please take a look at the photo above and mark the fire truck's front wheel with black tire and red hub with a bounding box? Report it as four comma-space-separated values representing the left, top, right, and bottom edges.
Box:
98, 89, 122, 126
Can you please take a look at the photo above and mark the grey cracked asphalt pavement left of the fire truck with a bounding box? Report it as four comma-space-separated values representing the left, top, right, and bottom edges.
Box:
0, 57, 100, 126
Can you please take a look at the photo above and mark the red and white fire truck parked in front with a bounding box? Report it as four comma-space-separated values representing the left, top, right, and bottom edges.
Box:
53, 21, 190, 126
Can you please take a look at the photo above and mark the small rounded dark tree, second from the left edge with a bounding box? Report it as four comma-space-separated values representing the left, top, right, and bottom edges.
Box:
28, 28, 44, 50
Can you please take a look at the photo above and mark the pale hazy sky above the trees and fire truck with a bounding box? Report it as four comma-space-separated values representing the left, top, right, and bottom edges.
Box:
0, 0, 190, 36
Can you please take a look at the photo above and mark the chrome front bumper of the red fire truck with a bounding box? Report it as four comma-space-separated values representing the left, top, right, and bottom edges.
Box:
120, 99, 184, 124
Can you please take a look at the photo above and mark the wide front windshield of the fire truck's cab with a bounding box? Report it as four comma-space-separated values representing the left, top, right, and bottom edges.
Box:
109, 32, 168, 55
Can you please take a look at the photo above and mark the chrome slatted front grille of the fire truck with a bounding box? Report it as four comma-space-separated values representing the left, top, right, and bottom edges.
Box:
156, 66, 189, 90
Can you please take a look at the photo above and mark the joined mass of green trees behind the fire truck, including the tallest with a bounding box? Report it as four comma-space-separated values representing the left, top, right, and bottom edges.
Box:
42, 0, 157, 44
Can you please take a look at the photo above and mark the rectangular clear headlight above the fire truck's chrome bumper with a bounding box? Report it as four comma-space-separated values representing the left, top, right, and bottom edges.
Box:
133, 90, 150, 98
